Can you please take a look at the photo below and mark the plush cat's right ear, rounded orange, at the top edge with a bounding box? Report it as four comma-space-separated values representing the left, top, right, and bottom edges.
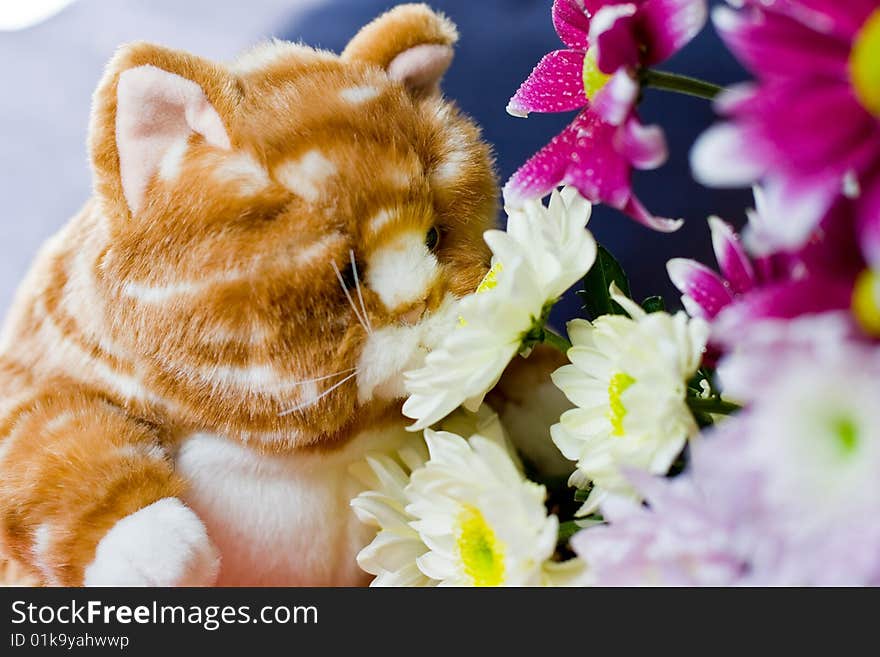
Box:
342, 4, 458, 95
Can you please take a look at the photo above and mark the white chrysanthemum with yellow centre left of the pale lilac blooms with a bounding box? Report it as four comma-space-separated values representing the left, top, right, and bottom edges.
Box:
551, 284, 709, 514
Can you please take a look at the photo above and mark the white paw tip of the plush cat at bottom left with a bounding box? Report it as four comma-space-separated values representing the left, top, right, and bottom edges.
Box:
85, 497, 220, 586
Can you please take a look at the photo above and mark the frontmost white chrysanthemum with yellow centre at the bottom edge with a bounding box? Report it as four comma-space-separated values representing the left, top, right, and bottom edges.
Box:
406, 429, 559, 586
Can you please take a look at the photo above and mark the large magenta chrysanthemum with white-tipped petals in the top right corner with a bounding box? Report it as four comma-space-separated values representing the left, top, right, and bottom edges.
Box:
692, 0, 880, 268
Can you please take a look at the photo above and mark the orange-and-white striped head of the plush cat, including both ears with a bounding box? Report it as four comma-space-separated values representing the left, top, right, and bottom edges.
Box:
90, 5, 497, 446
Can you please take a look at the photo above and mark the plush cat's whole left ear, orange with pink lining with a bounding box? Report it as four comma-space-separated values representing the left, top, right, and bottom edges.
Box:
89, 43, 240, 215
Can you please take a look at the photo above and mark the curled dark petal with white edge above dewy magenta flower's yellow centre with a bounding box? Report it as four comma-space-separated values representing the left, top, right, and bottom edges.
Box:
589, 3, 640, 75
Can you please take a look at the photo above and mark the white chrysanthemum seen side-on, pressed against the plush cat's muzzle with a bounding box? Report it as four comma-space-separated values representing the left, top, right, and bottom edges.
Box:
403, 188, 596, 431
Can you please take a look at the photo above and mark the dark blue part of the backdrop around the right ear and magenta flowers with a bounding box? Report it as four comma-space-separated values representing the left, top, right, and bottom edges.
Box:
280, 0, 751, 323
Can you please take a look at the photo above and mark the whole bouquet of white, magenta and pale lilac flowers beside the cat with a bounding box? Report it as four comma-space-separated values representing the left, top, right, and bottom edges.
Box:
352, 0, 880, 586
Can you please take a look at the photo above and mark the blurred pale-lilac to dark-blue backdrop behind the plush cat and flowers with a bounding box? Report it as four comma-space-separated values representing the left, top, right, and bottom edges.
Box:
0, 0, 751, 323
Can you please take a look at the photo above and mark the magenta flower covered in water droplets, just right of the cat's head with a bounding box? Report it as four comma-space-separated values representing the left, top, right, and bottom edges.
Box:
504, 0, 706, 231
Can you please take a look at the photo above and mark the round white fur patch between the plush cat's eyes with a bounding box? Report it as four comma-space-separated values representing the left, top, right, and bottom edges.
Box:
367, 232, 439, 310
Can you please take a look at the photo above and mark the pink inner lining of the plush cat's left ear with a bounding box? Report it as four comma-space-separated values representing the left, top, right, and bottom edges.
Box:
116, 66, 230, 212
